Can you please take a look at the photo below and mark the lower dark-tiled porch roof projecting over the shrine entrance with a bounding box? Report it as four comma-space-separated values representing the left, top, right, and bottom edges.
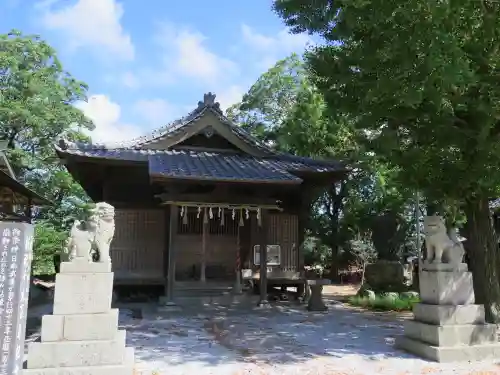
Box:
148, 151, 302, 184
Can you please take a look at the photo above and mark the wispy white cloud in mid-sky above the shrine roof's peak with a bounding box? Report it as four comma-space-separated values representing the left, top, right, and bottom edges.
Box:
156, 23, 238, 84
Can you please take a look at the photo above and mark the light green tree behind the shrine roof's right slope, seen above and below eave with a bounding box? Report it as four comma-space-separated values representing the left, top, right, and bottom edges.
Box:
228, 55, 356, 273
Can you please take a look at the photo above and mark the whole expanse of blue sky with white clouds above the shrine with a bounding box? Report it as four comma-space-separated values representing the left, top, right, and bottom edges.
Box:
0, 0, 311, 141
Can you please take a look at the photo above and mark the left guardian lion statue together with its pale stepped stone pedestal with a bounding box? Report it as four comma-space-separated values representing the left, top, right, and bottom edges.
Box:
23, 203, 134, 375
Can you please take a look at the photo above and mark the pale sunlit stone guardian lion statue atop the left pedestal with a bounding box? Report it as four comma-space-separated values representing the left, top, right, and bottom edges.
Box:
67, 202, 115, 263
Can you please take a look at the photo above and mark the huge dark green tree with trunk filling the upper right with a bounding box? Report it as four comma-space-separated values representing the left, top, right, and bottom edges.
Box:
274, 0, 500, 321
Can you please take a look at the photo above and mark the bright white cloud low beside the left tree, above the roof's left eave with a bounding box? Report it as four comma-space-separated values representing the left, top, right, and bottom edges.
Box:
77, 94, 143, 142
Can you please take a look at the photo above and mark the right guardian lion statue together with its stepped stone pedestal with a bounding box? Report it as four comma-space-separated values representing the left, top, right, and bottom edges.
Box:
395, 216, 500, 362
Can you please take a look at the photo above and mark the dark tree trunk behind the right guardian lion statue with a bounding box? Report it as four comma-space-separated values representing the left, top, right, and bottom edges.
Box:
464, 197, 500, 323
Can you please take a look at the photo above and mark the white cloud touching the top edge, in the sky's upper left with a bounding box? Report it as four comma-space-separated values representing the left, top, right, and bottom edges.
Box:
40, 0, 134, 60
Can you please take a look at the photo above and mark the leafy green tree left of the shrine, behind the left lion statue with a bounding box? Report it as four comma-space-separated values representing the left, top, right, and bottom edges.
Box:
0, 31, 93, 274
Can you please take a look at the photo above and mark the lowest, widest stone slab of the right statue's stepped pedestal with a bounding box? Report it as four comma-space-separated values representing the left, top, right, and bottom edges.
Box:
394, 336, 500, 363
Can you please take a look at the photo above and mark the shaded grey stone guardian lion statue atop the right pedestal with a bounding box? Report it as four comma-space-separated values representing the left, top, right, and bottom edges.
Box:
424, 216, 465, 266
